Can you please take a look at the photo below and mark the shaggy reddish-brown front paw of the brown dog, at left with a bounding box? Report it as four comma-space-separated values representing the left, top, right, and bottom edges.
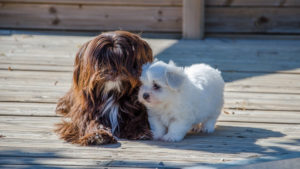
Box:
79, 130, 117, 146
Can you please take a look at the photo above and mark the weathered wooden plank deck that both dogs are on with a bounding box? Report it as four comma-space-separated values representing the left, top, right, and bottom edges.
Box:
0, 34, 300, 169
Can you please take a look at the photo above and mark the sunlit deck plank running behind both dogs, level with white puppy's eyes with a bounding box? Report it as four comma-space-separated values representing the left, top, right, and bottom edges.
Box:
0, 75, 300, 94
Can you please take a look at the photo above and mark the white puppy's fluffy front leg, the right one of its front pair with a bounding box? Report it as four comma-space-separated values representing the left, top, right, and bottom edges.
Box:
162, 121, 192, 142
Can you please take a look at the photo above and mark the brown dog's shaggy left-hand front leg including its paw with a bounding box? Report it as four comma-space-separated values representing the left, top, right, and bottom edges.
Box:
79, 121, 117, 146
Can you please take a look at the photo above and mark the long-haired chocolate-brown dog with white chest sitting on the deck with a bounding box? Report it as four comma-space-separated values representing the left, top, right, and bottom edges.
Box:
55, 31, 153, 145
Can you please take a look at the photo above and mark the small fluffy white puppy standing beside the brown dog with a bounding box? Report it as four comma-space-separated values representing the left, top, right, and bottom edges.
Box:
138, 61, 224, 141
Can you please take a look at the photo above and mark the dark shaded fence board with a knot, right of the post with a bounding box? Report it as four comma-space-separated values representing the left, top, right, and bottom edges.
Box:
205, 7, 300, 33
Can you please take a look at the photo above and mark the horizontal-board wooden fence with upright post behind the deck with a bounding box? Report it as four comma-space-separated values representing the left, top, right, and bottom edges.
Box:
0, 0, 300, 36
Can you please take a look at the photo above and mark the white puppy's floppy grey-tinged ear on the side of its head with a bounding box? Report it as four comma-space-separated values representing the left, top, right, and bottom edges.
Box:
166, 70, 185, 90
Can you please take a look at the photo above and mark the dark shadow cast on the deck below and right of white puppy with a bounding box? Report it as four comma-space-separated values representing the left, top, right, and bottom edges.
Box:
135, 125, 300, 156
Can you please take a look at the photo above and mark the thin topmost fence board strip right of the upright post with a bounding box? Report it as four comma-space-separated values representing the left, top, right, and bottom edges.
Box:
206, 0, 300, 7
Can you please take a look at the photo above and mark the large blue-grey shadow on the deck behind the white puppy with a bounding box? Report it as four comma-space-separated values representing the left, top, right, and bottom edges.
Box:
156, 38, 300, 82
